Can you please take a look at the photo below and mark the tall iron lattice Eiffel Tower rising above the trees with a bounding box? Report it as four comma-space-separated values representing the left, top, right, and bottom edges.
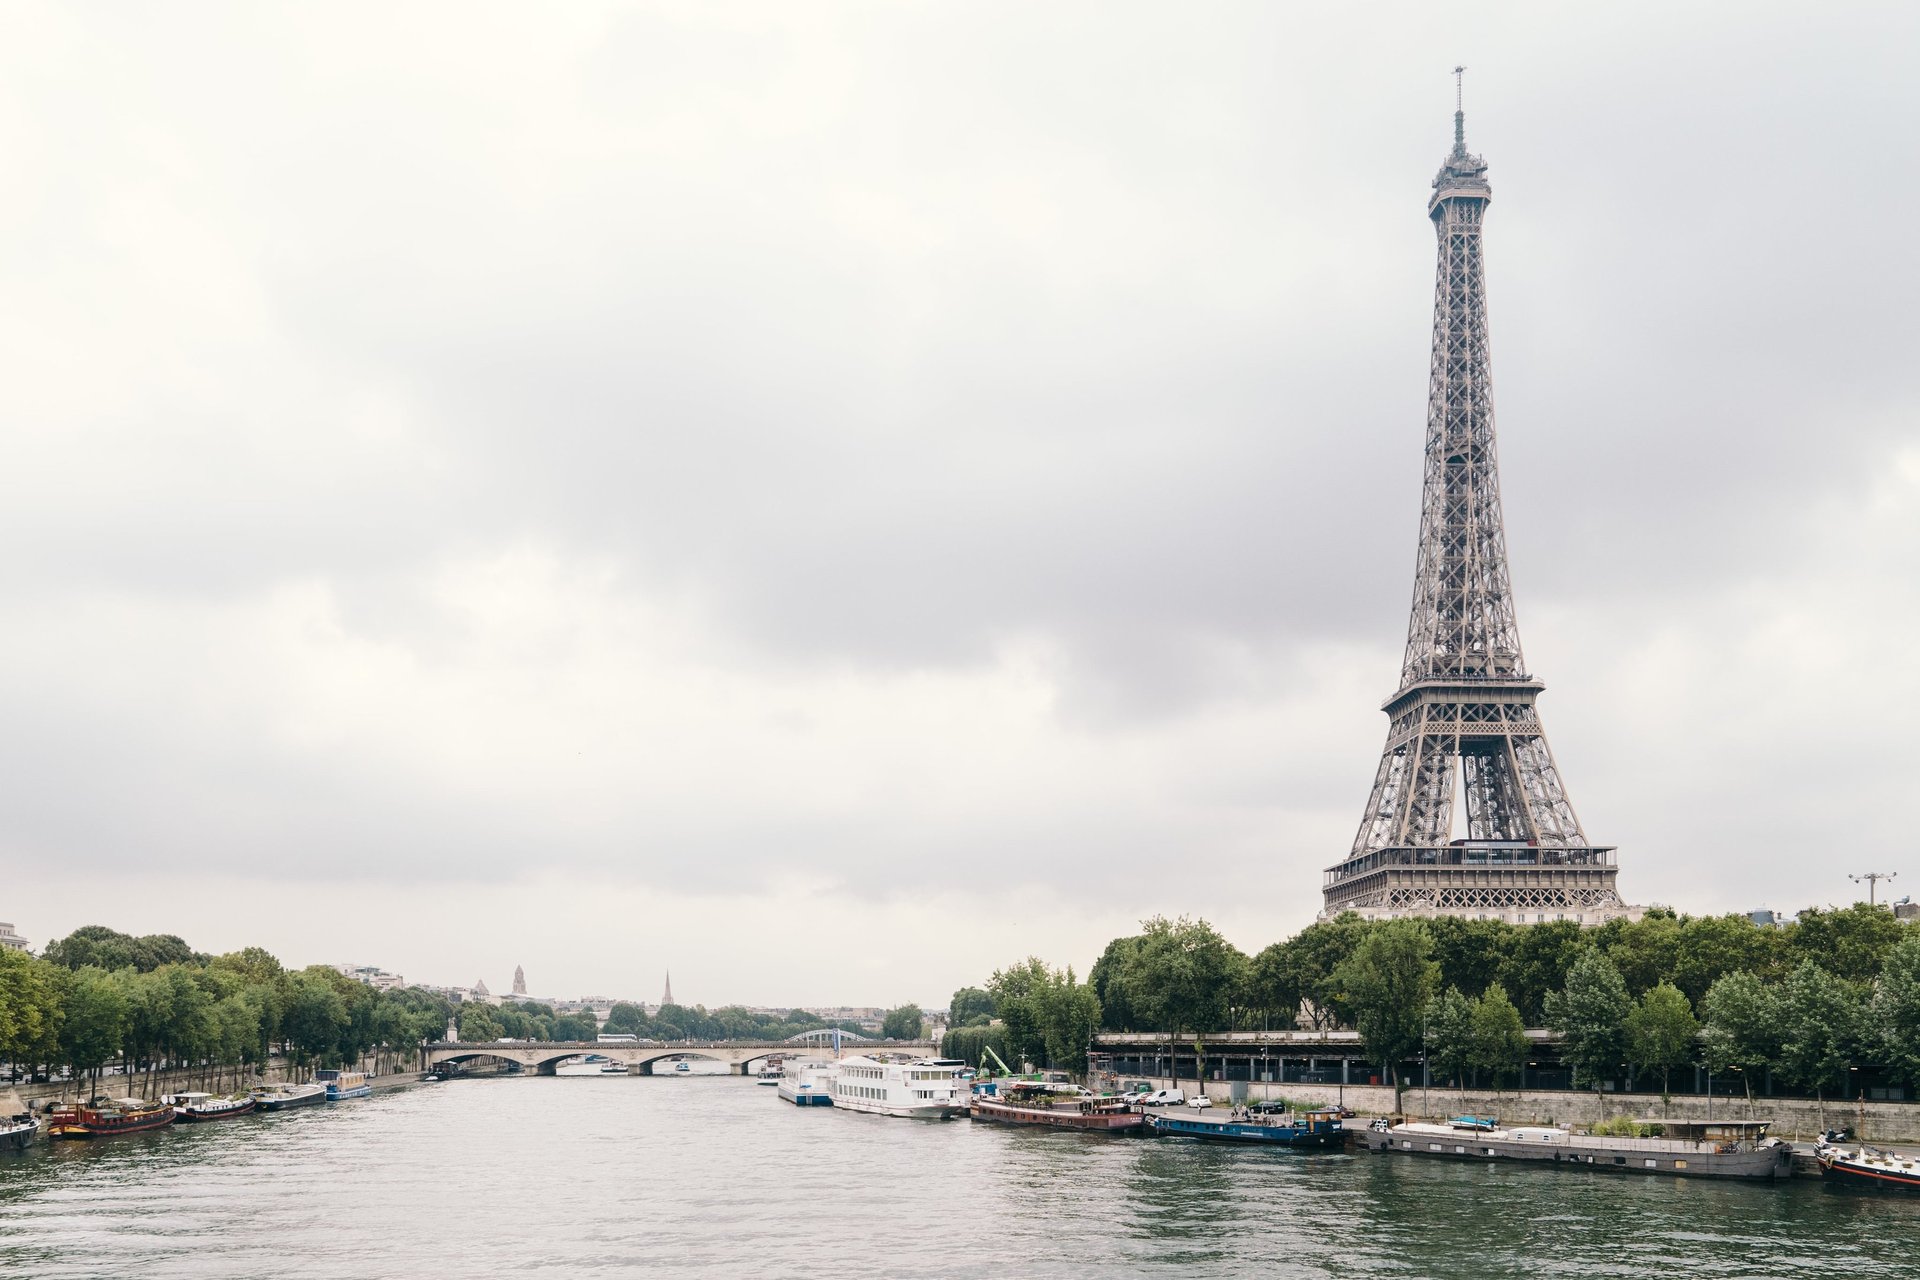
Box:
1323, 77, 1630, 925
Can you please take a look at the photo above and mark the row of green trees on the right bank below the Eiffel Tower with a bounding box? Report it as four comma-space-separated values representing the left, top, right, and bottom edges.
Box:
948, 904, 1920, 1094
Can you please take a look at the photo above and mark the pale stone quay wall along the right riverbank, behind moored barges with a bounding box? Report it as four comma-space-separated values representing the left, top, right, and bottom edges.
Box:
1144, 1077, 1920, 1142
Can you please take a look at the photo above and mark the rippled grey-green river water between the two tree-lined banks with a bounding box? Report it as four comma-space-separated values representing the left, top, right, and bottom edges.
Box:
0, 1077, 1920, 1280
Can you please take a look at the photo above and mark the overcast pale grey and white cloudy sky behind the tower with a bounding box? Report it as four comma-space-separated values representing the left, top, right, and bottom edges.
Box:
0, 0, 1920, 1004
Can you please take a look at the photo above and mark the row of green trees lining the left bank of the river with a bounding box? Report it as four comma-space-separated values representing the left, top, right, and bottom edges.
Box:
0, 925, 451, 1086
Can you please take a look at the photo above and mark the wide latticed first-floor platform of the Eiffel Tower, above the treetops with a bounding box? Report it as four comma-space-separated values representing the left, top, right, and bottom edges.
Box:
1321, 841, 1640, 925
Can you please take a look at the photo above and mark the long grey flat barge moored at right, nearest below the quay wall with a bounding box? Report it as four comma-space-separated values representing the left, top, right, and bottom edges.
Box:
1359, 1119, 1793, 1180
